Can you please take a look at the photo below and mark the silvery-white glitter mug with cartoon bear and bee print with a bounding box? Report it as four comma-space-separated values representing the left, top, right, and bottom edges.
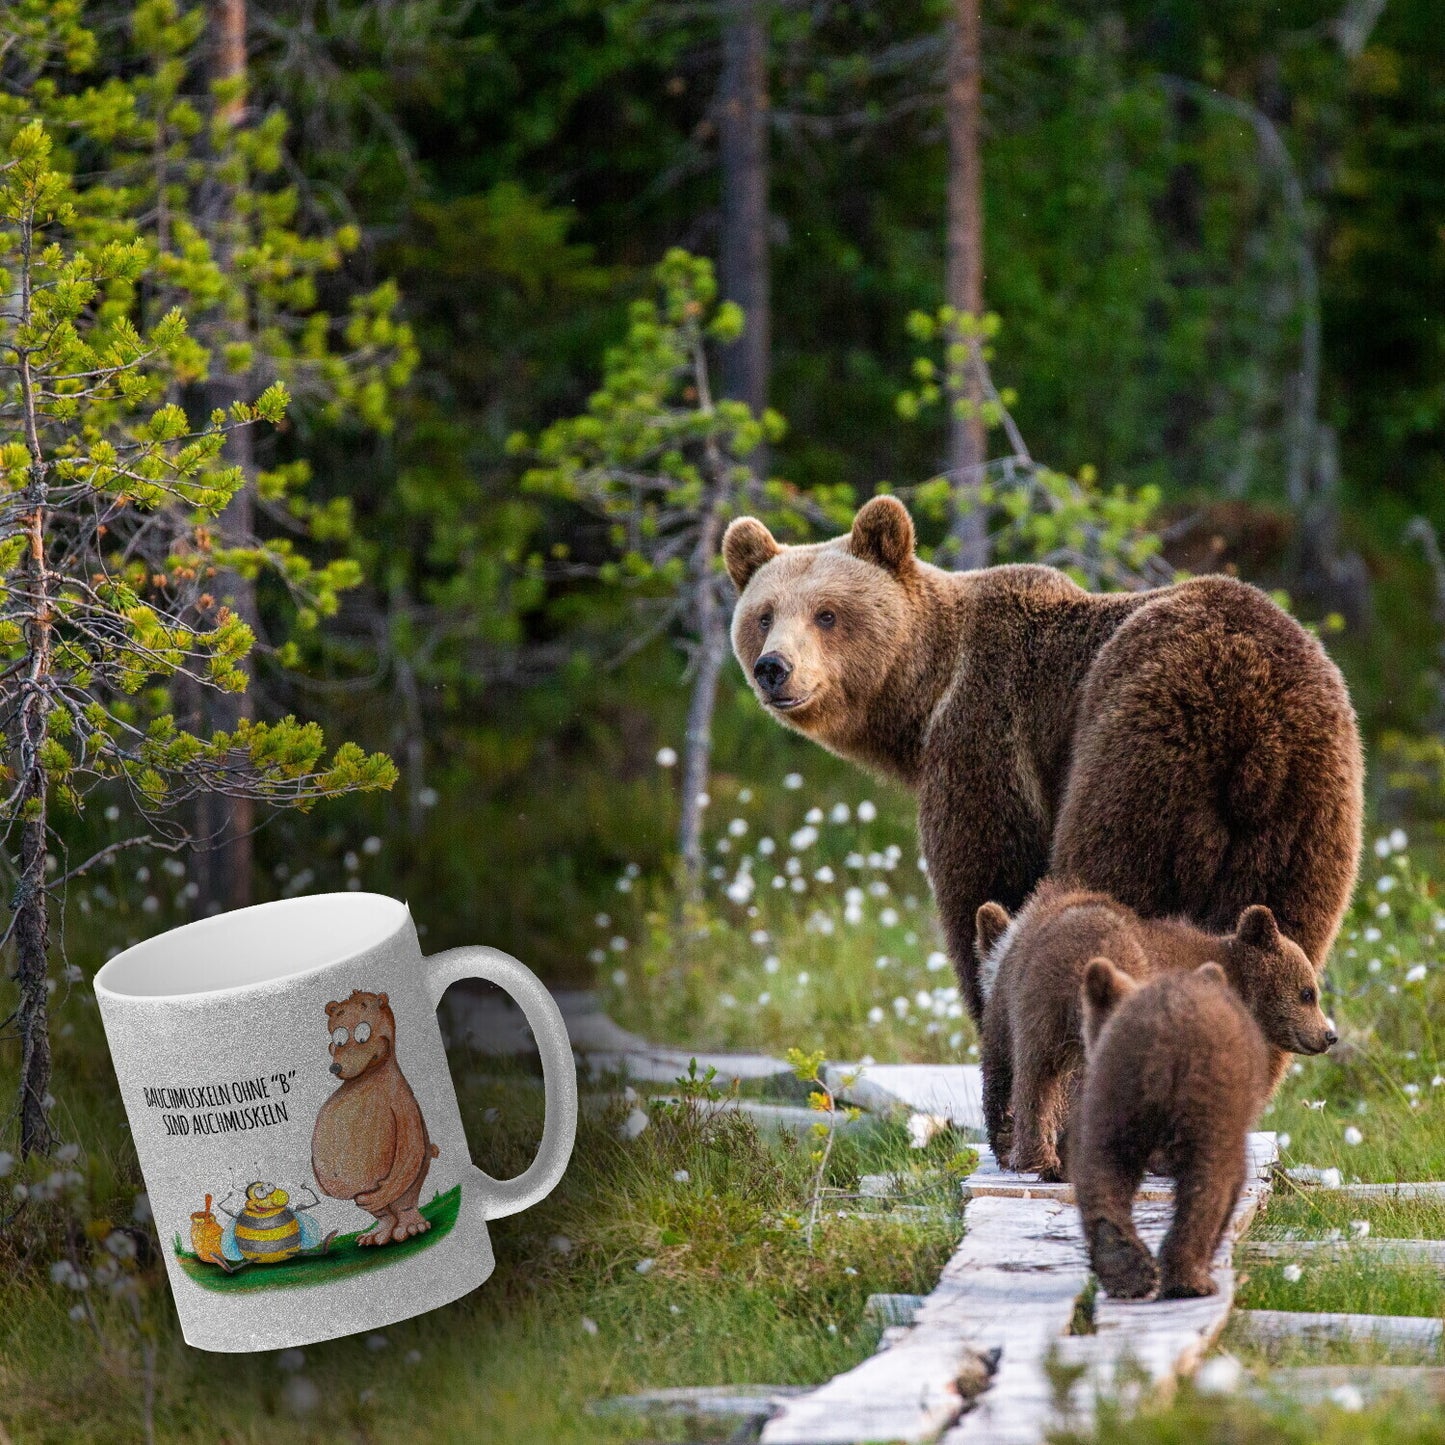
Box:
95, 893, 577, 1351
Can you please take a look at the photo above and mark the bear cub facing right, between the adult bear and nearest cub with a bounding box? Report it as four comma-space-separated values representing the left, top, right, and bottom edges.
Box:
974, 879, 1335, 1181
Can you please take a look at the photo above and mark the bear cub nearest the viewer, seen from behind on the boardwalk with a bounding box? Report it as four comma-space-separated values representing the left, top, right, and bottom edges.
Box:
1069, 958, 1287, 1299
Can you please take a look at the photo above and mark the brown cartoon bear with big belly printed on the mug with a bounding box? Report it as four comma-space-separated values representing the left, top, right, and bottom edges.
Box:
311, 988, 441, 1244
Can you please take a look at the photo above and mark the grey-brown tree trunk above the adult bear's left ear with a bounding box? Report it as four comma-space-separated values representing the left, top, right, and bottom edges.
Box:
718, 0, 772, 475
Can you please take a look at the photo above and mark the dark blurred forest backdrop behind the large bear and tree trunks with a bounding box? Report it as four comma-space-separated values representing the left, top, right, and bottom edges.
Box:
9, 0, 1445, 980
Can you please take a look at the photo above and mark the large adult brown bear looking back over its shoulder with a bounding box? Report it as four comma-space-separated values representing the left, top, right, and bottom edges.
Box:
723, 497, 1363, 1022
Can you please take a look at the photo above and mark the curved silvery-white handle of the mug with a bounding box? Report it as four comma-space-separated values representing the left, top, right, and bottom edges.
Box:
422, 944, 577, 1220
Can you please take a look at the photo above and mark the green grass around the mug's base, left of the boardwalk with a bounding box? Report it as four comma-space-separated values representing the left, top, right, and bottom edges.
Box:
0, 971, 965, 1445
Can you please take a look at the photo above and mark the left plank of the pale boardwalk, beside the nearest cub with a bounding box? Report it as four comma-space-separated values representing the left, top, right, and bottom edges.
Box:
762, 1199, 1088, 1445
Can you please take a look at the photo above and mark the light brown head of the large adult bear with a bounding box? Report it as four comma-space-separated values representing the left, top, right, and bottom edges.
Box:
723, 497, 918, 740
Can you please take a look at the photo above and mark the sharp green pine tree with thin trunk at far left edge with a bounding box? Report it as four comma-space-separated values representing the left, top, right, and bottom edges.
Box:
0, 120, 396, 1152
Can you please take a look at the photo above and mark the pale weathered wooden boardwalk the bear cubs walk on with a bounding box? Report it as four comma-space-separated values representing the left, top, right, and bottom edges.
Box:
762, 1134, 1276, 1445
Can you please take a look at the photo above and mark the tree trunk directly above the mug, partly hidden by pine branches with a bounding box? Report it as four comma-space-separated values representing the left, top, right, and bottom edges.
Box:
195, 0, 260, 913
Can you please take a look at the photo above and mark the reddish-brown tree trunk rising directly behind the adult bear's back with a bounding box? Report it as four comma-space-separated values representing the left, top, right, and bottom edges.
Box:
944, 0, 988, 568
